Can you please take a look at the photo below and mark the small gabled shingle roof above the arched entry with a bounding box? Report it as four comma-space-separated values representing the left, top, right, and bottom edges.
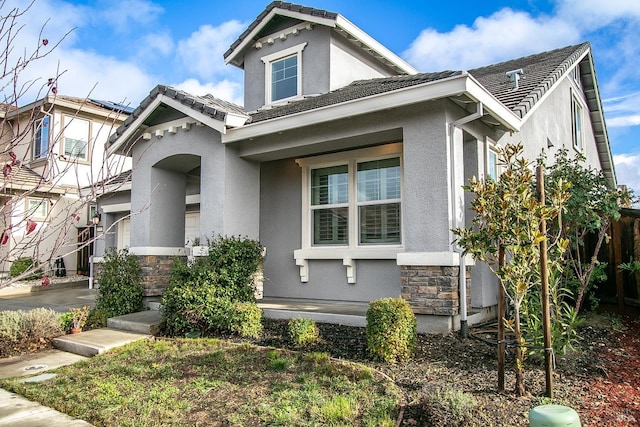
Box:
109, 85, 247, 144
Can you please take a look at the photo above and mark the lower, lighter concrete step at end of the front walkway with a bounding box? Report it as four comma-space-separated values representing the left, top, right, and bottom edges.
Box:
53, 328, 150, 357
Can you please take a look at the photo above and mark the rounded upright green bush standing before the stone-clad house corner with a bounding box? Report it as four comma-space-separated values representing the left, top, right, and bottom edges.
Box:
366, 298, 416, 363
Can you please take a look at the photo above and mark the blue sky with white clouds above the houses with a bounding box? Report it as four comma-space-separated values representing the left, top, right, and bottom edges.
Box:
8, 0, 640, 195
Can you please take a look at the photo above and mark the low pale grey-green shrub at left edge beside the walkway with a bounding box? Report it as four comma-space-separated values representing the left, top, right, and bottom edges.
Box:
0, 308, 64, 357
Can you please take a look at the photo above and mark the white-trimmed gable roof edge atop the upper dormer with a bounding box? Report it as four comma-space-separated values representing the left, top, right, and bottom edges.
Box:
223, 1, 418, 74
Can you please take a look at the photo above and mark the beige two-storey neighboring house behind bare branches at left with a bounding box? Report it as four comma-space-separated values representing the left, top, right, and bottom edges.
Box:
0, 94, 131, 275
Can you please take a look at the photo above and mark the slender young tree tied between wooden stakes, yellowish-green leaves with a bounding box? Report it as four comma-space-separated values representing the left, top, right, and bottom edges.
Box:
453, 144, 568, 396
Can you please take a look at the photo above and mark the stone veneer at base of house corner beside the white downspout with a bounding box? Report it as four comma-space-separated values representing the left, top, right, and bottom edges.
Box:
400, 265, 471, 316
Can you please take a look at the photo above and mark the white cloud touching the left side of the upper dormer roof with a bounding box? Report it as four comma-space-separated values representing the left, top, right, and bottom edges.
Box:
178, 20, 245, 79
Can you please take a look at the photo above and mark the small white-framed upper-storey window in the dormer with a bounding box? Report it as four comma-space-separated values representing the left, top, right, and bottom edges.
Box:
261, 43, 307, 105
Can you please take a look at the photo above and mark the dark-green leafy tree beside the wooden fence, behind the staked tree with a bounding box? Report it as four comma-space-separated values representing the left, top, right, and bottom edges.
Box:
538, 149, 630, 313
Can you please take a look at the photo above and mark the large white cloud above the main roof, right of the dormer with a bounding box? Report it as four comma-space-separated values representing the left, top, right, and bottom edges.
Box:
403, 8, 579, 71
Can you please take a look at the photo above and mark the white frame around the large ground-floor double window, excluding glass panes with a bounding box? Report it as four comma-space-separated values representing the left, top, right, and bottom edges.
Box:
295, 143, 404, 265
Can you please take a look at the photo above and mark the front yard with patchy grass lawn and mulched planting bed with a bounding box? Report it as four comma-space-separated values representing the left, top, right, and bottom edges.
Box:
0, 314, 640, 426
